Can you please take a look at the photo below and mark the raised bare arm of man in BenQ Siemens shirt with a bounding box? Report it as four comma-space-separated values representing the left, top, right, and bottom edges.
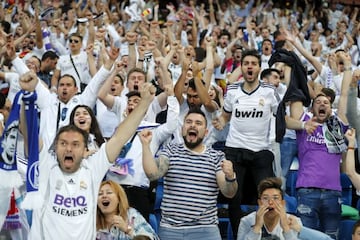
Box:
106, 83, 156, 163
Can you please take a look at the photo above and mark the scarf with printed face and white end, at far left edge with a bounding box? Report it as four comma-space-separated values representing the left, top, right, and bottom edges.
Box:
0, 92, 23, 227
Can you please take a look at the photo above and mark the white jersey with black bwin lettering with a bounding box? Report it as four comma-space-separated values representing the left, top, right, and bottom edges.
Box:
224, 83, 278, 151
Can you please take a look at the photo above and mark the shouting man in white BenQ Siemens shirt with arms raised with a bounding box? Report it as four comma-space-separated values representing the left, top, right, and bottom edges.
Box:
20, 73, 155, 240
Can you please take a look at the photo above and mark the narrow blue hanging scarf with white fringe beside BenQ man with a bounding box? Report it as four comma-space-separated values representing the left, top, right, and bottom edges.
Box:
21, 92, 43, 209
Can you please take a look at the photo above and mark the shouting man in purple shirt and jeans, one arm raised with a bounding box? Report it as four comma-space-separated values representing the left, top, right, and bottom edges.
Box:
286, 52, 352, 239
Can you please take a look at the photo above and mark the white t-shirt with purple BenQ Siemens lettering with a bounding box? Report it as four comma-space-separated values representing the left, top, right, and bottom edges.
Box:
30, 144, 110, 240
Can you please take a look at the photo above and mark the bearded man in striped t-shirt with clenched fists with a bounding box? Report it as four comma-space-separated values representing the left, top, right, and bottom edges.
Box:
140, 108, 237, 240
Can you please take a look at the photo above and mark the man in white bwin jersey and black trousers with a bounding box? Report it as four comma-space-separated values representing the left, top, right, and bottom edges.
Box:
213, 50, 278, 239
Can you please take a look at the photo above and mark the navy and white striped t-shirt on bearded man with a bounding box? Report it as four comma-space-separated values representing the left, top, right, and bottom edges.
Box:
160, 143, 225, 228
